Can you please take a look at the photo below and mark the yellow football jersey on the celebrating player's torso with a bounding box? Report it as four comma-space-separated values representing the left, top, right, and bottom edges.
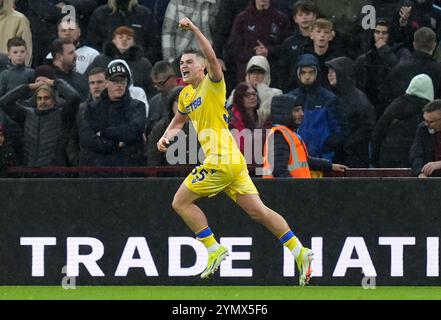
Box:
178, 75, 243, 163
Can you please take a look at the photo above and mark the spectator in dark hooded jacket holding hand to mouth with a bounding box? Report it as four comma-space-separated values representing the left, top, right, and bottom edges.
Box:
355, 18, 411, 118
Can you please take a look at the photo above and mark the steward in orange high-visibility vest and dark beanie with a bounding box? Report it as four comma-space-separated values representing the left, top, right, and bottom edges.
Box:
263, 95, 348, 179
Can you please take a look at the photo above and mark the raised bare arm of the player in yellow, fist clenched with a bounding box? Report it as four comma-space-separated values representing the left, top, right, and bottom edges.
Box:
179, 18, 223, 82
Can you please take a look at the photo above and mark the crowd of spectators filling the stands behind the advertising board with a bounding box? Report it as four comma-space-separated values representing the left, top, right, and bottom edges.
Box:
0, 0, 441, 175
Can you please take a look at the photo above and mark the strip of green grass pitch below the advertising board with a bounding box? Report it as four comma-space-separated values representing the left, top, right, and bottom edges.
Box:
0, 286, 441, 300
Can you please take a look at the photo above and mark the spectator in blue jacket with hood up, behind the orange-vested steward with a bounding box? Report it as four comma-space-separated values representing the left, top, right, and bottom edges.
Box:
289, 54, 345, 160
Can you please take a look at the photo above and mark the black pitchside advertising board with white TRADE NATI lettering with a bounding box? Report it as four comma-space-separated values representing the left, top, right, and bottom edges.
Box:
0, 178, 441, 286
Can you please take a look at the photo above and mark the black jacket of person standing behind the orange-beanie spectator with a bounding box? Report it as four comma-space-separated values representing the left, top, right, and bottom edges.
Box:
87, 0, 162, 62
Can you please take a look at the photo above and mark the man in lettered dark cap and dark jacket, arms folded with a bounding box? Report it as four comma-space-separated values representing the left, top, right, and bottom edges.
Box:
80, 59, 146, 167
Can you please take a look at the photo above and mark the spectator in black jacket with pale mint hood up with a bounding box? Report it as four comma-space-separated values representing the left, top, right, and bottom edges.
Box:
372, 74, 433, 168
